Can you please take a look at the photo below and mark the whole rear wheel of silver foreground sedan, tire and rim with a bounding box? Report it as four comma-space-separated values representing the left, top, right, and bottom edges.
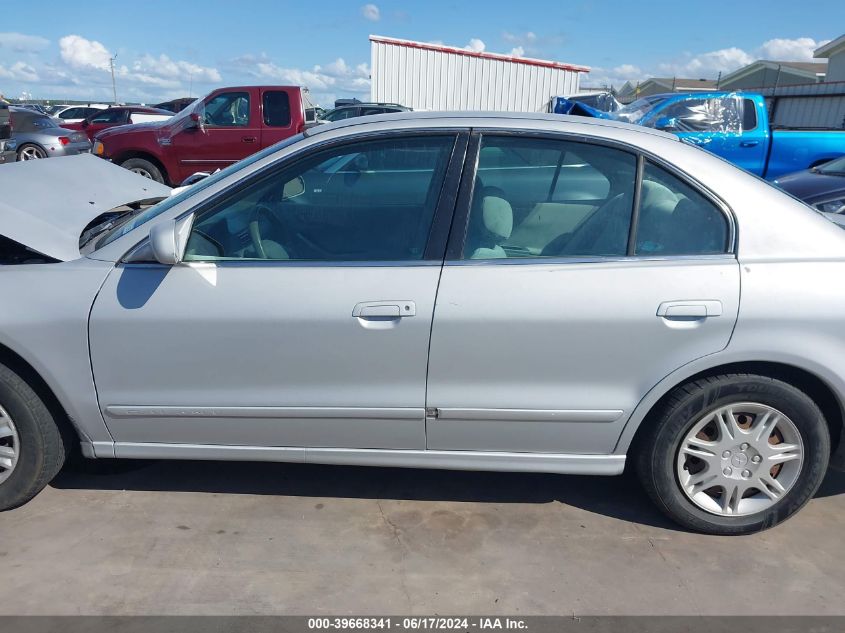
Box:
633, 374, 830, 535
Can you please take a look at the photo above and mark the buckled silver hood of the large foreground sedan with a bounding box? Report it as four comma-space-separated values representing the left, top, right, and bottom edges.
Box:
0, 154, 170, 261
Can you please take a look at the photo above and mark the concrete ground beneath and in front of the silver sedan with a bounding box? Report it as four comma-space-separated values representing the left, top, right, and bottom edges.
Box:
0, 461, 845, 615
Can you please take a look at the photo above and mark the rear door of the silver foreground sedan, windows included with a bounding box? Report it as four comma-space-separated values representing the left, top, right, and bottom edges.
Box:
427, 133, 739, 454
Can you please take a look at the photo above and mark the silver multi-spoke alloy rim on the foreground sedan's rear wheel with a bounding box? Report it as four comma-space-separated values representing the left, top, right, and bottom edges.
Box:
676, 402, 804, 516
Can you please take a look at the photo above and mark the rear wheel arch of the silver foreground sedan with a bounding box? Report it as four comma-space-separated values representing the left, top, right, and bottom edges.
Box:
615, 360, 845, 454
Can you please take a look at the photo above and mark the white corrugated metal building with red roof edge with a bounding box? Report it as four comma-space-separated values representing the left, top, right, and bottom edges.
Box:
370, 35, 590, 112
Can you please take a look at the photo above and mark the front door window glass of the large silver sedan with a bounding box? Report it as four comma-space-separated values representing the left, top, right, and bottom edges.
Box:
184, 135, 454, 262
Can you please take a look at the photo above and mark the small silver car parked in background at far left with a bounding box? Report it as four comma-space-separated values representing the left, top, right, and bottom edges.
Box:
10, 107, 91, 160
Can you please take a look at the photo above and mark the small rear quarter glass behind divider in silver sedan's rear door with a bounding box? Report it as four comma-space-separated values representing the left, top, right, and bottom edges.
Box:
636, 162, 729, 256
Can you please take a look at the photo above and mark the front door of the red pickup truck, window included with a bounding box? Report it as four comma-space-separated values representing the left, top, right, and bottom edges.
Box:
171, 90, 261, 182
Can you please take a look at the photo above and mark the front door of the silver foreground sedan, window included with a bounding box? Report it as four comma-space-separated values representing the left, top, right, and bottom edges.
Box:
90, 133, 466, 449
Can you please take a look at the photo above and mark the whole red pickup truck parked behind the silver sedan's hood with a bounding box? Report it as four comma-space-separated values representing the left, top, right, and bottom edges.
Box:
93, 86, 314, 186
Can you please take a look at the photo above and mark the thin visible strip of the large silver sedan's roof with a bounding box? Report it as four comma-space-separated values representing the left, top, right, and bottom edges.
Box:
305, 110, 679, 141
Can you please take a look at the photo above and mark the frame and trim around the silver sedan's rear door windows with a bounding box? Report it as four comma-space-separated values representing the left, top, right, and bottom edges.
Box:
446, 129, 737, 266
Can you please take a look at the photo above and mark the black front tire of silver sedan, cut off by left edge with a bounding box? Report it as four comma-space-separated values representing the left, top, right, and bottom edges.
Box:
0, 365, 68, 511
